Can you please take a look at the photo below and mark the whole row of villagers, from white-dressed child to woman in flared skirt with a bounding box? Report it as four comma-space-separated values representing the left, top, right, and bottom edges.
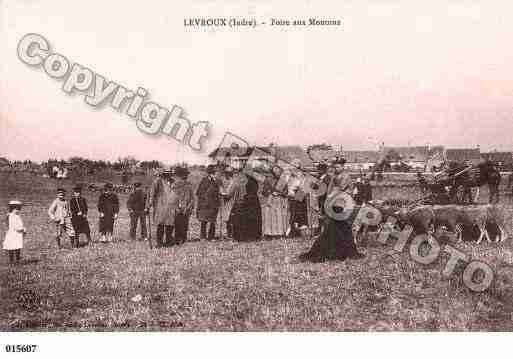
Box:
4, 160, 372, 261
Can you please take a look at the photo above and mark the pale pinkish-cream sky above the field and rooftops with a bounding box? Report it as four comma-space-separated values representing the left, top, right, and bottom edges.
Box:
0, 0, 513, 163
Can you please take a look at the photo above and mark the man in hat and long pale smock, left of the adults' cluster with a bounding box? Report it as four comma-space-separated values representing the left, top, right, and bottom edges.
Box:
146, 169, 178, 247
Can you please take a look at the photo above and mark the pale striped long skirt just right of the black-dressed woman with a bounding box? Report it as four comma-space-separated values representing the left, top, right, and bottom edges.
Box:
262, 196, 290, 236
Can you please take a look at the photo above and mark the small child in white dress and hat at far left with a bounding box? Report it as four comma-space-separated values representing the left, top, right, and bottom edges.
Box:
3, 201, 27, 264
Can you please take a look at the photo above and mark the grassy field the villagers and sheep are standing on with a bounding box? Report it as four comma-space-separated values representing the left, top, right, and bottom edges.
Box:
0, 174, 513, 331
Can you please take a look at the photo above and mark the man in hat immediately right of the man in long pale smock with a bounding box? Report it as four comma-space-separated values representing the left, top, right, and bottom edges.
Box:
173, 167, 194, 244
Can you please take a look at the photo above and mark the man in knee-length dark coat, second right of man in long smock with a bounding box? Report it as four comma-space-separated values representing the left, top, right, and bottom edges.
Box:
196, 165, 221, 240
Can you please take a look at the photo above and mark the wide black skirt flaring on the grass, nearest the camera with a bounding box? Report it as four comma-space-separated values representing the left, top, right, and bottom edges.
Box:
299, 218, 358, 262
